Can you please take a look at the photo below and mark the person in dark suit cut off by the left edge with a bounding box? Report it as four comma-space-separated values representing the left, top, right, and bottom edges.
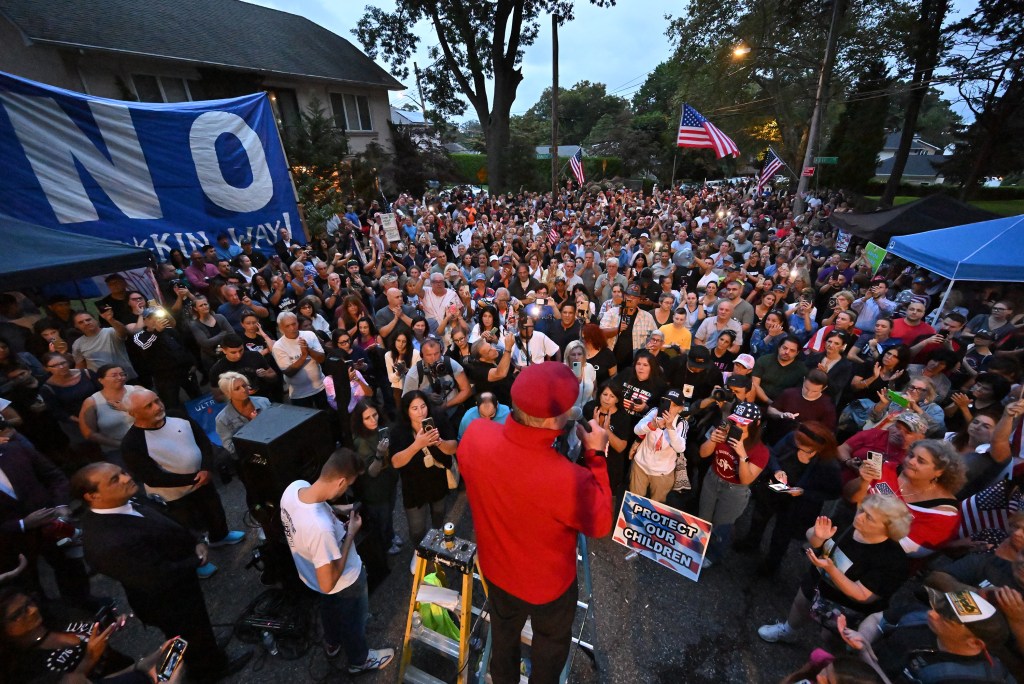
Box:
0, 428, 95, 608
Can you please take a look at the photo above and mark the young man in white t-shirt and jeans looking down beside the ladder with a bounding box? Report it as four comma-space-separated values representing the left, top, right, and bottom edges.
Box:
281, 447, 394, 675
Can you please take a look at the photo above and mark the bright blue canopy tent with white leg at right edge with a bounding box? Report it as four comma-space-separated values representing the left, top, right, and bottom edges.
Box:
887, 215, 1024, 311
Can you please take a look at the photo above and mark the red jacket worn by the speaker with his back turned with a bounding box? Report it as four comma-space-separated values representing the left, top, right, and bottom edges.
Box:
457, 417, 612, 605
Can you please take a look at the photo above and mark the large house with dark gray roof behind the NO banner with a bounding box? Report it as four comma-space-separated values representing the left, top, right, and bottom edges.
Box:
0, 0, 404, 153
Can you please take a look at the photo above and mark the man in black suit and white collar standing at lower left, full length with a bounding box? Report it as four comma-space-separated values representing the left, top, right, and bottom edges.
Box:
71, 463, 252, 682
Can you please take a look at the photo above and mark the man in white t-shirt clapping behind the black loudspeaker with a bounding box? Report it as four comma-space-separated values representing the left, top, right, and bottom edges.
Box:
271, 311, 331, 411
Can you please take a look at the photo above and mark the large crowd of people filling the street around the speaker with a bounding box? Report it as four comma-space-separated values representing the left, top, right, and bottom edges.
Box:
0, 180, 1024, 681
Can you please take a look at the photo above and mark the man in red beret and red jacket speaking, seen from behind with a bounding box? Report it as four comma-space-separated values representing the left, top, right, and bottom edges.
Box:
458, 361, 612, 684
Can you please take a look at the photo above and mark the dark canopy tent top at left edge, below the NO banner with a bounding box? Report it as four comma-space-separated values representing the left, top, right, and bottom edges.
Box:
0, 215, 156, 290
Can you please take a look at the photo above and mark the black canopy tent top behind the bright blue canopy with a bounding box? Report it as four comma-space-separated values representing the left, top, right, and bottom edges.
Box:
829, 195, 998, 245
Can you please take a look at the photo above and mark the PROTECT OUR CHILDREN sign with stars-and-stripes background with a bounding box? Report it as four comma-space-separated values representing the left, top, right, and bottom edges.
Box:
611, 491, 711, 582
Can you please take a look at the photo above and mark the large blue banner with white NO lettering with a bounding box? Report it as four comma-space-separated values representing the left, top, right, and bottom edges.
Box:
0, 73, 303, 260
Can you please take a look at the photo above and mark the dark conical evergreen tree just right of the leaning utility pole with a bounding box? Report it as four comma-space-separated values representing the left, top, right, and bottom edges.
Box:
821, 59, 892, 191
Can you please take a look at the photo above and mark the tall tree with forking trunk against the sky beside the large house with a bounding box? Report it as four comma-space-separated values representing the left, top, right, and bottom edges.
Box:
353, 0, 614, 191
